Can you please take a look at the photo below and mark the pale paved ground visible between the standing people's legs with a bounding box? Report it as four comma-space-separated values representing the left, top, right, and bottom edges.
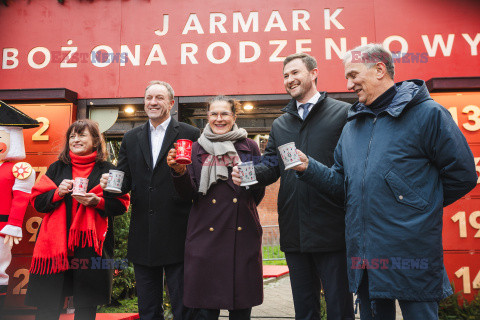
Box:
220, 276, 402, 320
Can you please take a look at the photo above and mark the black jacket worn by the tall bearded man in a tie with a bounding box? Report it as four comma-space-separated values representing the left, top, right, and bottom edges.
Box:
255, 92, 350, 253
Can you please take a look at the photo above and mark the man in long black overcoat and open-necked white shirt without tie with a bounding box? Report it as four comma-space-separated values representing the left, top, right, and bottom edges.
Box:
105, 81, 200, 320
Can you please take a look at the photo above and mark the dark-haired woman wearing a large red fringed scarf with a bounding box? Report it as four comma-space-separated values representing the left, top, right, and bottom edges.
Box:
26, 120, 130, 320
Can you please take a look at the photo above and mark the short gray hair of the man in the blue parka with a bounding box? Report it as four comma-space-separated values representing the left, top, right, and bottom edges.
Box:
343, 43, 395, 80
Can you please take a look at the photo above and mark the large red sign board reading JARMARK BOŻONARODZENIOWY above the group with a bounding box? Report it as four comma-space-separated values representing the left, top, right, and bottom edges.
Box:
0, 0, 480, 98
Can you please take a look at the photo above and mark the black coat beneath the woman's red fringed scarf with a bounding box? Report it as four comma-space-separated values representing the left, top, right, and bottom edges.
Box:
25, 161, 126, 307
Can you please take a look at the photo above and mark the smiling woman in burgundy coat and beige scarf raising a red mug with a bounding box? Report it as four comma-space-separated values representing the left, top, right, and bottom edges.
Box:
167, 96, 265, 320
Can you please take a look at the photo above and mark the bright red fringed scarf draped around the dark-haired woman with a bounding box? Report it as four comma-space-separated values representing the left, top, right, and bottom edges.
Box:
30, 152, 122, 274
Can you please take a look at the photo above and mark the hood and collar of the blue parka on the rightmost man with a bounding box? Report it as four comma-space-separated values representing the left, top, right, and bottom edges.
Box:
347, 79, 431, 121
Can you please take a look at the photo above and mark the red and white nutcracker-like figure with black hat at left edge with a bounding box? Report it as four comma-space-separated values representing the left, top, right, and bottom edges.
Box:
0, 101, 39, 314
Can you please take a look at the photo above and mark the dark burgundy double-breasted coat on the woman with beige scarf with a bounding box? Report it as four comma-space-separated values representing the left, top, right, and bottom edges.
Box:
174, 139, 265, 310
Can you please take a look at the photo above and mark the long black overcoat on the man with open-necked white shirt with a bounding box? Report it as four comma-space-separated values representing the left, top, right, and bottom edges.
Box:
117, 118, 200, 267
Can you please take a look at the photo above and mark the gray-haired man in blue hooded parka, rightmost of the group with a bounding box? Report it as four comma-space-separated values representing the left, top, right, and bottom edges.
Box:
295, 44, 477, 320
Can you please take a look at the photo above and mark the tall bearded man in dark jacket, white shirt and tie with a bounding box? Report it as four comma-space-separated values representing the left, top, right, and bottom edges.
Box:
233, 53, 354, 320
